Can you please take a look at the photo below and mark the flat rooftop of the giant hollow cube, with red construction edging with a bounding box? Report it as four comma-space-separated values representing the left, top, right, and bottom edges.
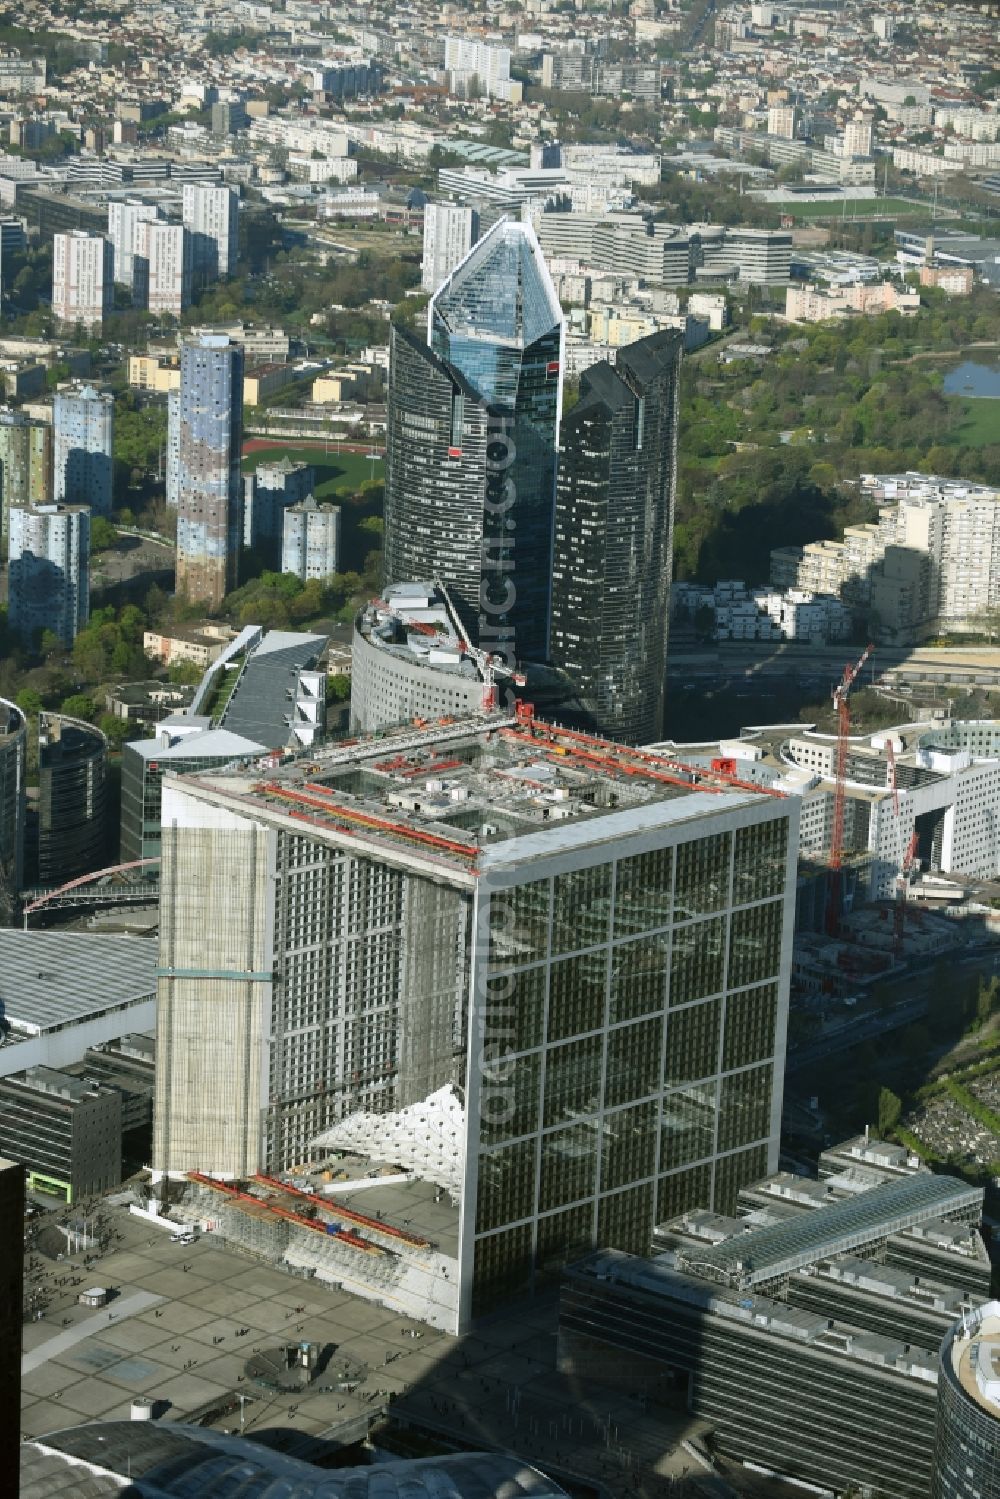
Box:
170, 705, 775, 874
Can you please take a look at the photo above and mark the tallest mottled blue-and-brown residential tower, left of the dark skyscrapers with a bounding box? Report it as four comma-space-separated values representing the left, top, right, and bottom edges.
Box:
168, 333, 243, 609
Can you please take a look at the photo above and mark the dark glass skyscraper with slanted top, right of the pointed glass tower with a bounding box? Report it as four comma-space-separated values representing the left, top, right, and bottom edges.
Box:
550, 331, 682, 744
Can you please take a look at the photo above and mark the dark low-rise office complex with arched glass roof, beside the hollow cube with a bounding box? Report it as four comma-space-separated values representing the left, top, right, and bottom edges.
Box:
559, 1168, 988, 1499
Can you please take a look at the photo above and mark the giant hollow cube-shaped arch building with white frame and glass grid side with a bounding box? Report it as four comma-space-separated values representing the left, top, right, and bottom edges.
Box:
153, 705, 798, 1328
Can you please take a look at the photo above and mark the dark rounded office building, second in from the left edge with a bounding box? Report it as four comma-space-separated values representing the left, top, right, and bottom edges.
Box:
37, 714, 108, 886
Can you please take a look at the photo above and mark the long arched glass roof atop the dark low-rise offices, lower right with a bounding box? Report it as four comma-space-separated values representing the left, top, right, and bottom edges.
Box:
678, 1172, 982, 1289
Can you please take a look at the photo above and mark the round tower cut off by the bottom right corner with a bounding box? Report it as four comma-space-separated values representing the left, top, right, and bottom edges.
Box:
931, 1301, 1000, 1499
